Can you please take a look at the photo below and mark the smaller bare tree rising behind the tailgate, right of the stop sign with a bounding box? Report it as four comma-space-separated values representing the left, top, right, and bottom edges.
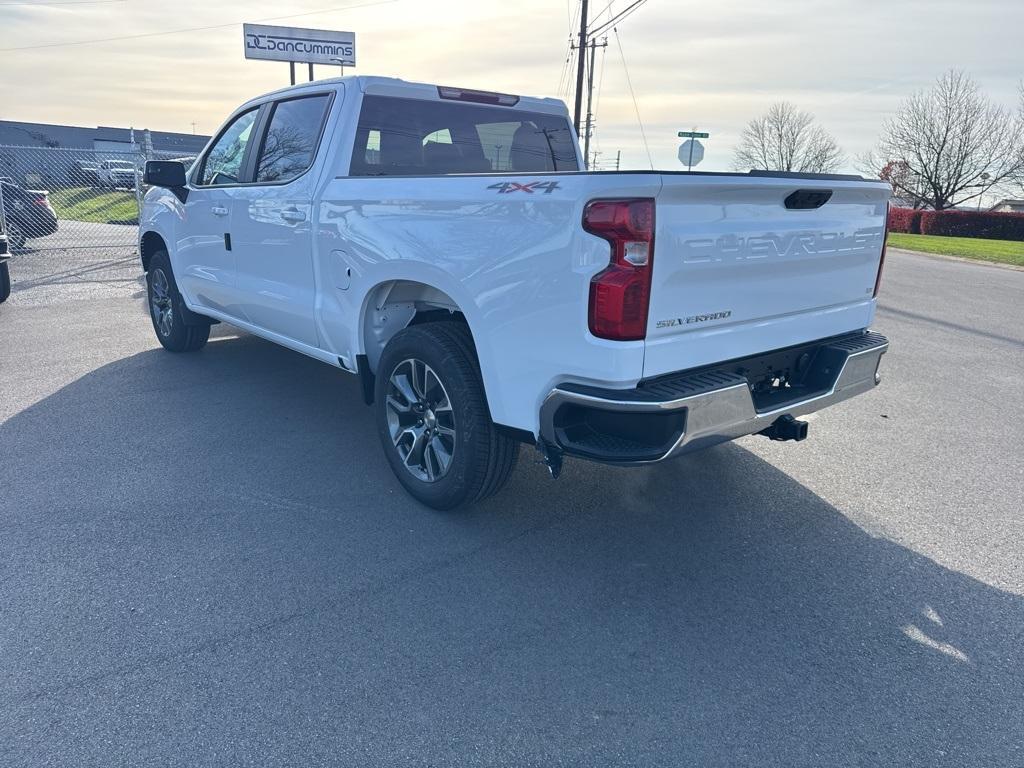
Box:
733, 101, 845, 173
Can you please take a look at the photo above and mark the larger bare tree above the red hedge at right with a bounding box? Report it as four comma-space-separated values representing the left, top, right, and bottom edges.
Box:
860, 70, 1024, 211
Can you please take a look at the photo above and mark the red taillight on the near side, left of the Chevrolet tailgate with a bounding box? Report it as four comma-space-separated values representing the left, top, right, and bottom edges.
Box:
583, 199, 654, 341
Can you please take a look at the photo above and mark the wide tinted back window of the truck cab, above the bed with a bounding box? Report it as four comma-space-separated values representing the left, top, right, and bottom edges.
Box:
349, 95, 580, 176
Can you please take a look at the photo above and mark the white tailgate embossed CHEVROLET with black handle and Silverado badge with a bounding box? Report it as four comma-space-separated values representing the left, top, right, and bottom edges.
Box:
644, 174, 890, 378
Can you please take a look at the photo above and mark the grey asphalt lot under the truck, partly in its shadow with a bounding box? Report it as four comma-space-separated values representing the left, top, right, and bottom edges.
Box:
0, 244, 1024, 767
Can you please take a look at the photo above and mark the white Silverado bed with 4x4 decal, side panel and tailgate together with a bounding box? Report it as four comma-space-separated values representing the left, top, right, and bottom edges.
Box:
318, 166, 890, 429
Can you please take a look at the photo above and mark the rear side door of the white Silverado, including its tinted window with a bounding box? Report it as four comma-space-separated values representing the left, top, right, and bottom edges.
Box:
231, 91, 331, 346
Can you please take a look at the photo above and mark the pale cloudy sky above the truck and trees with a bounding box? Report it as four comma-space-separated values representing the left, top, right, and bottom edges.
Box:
0, 0, 1024, 170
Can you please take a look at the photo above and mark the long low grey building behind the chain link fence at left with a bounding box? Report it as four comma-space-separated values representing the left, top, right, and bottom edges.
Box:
0, 120, 210, 187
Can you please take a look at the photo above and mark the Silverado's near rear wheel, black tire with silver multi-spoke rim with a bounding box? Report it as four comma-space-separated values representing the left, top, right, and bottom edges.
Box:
374, 322, 519, 510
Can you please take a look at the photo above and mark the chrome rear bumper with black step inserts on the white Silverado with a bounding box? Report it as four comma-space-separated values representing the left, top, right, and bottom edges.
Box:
541, 332, 889, 464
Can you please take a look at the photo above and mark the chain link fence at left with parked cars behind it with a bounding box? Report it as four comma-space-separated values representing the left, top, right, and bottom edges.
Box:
0, 145, 195, 254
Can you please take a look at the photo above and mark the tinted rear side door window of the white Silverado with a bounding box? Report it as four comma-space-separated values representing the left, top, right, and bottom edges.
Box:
256, 93, 330, 183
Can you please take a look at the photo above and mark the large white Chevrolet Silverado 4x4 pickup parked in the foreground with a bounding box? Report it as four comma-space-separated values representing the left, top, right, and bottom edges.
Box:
139, 77, 889, 509
